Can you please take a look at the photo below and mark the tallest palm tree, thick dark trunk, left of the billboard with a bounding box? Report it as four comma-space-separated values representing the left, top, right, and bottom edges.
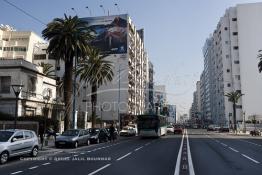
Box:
42, 15, 91, 130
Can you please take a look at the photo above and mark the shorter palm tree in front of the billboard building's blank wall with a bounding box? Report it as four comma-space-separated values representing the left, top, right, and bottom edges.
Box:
77, 48, 114, 127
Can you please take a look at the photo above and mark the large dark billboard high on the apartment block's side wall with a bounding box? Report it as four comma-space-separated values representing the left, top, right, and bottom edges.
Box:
82, 15, 127, 54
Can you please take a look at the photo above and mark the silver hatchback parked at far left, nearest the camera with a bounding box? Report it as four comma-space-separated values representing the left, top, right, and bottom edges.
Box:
0, 129, 39, 164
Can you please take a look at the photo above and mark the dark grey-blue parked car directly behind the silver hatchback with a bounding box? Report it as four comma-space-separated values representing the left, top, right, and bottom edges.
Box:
55, 129, 90, 148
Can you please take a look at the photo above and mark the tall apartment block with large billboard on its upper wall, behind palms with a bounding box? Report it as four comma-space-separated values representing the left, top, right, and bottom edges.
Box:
34, 14, 153, 125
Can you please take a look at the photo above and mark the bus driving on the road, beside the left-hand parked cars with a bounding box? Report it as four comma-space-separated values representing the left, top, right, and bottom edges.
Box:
137, 114, 167, 137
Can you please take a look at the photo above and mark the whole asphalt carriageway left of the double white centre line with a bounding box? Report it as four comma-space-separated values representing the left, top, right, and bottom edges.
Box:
0, 135, 181, 175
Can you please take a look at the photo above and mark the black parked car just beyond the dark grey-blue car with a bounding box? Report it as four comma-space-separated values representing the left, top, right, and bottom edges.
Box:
89, 128, 110, 143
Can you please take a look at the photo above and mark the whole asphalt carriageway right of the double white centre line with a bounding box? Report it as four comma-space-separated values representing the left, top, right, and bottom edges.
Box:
188, 130, 262, 175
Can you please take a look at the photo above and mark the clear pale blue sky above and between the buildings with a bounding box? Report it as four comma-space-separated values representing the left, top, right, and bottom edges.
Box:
0, 0, 257, 113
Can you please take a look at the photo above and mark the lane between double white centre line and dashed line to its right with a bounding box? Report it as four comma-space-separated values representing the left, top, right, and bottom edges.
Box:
189, 130, 262, 175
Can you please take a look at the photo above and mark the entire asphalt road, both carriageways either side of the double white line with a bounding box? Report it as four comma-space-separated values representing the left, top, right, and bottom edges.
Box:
0, 129, 262, 175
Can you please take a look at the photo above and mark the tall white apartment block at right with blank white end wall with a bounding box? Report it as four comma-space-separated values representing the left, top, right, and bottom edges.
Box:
201, 3, 262, 124
